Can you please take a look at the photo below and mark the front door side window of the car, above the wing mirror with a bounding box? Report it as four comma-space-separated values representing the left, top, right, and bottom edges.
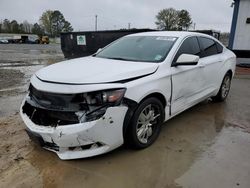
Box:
174, 37, 201, 62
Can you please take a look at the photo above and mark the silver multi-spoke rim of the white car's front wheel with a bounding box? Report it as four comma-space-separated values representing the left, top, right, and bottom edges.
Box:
136, 104, 160, 144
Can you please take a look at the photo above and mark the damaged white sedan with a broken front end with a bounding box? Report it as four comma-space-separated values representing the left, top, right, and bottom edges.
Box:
20, 32, 236, 159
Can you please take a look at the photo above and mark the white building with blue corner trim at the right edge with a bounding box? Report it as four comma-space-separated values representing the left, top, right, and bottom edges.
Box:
228, 0, 250, 57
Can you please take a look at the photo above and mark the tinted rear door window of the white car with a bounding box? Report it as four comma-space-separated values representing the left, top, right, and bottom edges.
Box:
199, 37, 218, 57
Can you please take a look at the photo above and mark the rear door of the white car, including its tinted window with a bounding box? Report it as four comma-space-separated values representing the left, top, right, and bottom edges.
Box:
198, 37, 224, 95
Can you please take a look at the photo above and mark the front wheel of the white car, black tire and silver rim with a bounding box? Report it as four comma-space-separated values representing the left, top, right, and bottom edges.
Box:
125, 98, 165, 149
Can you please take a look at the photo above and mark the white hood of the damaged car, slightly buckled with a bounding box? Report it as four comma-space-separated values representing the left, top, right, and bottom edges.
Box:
36, 56, 158, 84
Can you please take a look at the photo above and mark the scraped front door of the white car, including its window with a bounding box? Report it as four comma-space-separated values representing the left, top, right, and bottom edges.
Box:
171, 36, 205, 115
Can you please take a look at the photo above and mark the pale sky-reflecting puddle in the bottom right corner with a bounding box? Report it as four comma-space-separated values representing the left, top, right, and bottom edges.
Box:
176, 127, 250, 188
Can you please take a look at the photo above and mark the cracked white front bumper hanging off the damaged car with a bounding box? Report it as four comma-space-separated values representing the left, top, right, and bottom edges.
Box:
20, 101, 128, 160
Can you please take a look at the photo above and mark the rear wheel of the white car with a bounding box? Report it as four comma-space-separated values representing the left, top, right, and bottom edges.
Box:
212, 73, 231, 102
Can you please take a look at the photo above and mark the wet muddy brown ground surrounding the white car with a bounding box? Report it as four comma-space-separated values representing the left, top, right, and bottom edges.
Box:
0, 45, 250, 188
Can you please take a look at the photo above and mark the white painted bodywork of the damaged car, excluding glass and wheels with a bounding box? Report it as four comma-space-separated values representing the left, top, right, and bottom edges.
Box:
20, 32, 236, 159
